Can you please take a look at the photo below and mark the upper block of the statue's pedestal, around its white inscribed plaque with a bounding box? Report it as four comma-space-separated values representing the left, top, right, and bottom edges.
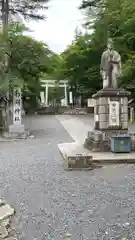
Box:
93, 88, 130, 131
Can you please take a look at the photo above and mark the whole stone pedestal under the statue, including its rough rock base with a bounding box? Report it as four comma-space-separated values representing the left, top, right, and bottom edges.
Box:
84, 88, 133, 152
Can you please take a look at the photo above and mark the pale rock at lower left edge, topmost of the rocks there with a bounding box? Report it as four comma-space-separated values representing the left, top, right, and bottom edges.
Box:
0, 204, 14, 221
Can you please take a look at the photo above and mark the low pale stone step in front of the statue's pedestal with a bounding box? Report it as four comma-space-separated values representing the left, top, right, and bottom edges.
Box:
58, 142, 135, 168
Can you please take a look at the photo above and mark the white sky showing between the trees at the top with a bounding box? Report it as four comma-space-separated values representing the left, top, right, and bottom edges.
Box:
29, 0, 84, 53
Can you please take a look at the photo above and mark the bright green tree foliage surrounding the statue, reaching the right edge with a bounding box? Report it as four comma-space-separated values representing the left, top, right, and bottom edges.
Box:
58, 0, 135, 96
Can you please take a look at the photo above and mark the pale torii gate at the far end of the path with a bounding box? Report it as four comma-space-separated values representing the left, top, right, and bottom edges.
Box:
40, 79, 68, 106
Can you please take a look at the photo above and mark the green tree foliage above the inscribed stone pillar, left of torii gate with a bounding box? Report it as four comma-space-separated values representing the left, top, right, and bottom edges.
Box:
0, 24, 56, 96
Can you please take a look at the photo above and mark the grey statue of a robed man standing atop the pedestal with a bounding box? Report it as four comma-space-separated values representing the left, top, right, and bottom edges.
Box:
100, 39, 121, 88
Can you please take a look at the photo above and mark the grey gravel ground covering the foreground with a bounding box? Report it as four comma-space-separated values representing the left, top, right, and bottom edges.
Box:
0, 116, 135, 240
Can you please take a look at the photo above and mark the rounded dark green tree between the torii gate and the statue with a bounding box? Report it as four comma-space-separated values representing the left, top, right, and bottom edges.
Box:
58, 35, 101, 97
